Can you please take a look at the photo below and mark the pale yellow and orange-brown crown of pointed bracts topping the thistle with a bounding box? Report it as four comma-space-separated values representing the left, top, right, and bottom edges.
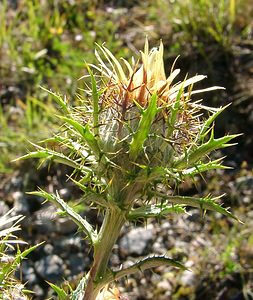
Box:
92, 39, 223, 109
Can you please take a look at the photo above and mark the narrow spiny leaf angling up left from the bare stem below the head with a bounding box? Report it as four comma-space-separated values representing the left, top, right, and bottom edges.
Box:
28, 189, 97, 244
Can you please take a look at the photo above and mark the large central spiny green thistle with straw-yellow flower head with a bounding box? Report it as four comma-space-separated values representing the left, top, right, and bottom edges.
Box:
16, 40, 240, 300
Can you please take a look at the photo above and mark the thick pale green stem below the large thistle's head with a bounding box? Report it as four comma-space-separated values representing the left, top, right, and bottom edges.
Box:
83, 207, 126, 300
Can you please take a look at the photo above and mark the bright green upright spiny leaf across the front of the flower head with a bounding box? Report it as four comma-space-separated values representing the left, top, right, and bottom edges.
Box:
129, 94, 158, 161
